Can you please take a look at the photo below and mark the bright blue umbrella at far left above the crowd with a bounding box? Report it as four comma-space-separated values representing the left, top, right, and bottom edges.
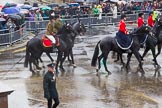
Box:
2, 7, 20, 14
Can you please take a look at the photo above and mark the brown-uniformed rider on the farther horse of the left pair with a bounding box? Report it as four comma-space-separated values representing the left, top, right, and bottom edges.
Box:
53, 14, 63, 46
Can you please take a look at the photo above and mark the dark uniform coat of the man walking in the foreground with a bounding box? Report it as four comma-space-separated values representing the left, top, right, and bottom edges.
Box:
43, 71, 58, 99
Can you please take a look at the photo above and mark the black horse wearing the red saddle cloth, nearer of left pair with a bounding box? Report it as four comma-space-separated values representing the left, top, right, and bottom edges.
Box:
24, 24, 72, 72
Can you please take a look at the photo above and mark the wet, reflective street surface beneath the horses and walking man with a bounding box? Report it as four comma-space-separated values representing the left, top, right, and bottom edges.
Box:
0, 26, 162, 108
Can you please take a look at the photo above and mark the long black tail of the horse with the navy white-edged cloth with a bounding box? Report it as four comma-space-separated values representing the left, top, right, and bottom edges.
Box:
91, 41, 100, 67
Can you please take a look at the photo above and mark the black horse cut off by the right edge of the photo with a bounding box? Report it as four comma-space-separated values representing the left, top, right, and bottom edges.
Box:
142, 17, 162, 67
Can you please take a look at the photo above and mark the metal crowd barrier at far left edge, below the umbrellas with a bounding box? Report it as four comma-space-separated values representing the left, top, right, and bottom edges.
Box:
0, 25, 27, 46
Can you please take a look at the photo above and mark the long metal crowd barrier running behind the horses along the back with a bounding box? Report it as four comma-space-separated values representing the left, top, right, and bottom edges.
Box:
26, 13, 148, 31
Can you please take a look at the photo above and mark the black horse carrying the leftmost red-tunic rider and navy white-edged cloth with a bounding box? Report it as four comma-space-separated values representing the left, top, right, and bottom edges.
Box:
91, 25, 151, 74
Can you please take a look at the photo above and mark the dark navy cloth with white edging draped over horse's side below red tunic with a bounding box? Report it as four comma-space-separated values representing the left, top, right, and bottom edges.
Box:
115, 31, 133, 50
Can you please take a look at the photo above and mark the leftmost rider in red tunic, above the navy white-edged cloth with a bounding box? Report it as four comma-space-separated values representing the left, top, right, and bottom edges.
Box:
119, 15, 128, 35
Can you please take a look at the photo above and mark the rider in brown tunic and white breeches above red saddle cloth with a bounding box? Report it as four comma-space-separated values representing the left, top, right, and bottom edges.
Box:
46, 15, 56, 46
